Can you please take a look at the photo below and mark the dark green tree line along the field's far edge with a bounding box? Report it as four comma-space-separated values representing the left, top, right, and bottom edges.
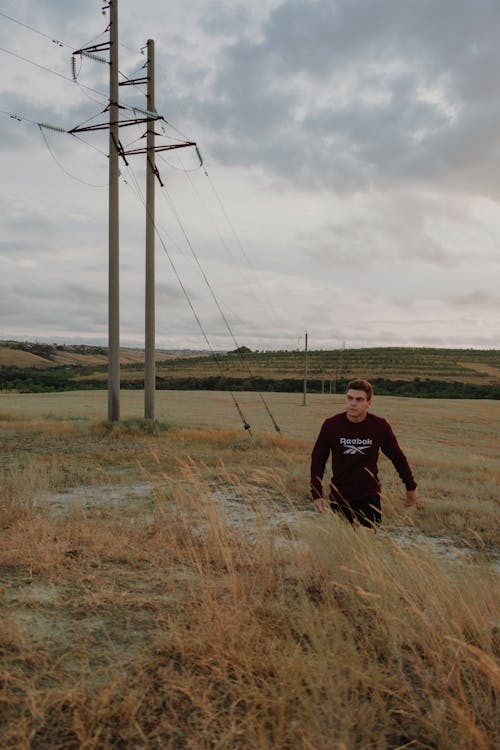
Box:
0, 365, 500, 399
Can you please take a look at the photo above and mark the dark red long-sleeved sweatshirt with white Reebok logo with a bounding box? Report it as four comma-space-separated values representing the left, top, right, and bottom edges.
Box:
311, 412, 417, 501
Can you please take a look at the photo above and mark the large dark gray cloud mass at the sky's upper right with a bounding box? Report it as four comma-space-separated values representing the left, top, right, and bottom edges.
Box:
163, 0, 500, 190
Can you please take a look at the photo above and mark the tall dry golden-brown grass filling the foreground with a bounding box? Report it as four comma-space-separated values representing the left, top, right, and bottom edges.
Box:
0, 435, 499, 750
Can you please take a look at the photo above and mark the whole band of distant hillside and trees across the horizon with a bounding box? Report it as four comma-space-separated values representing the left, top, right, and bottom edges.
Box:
0, 342, 500, 399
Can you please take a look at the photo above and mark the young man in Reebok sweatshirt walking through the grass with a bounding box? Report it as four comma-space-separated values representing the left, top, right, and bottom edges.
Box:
311, 380, 417, 527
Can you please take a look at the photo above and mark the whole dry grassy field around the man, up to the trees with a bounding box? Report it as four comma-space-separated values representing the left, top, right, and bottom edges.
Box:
0, 391, 500, 750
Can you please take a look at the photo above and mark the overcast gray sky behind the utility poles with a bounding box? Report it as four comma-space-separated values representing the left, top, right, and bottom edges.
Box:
0, 0, 500, 349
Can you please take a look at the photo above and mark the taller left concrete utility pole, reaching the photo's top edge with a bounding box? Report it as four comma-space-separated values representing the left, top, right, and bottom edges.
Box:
108, 0, 120, 422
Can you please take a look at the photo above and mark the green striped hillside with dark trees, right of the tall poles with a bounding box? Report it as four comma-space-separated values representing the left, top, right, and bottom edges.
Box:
152, 347, 500, 398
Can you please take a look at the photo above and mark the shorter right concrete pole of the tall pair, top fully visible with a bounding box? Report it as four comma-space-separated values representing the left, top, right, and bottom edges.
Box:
144, 39, 156, 419
